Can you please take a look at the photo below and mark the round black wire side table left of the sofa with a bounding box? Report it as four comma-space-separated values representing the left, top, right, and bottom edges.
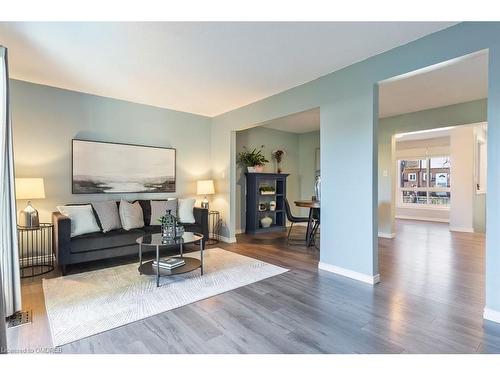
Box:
17, 223, 54, 278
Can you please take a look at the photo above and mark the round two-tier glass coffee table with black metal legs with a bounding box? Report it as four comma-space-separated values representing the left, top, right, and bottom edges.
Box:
136, 232, 204, 286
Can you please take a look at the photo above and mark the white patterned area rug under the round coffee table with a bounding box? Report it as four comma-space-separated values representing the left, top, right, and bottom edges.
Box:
43, 248, 288, 346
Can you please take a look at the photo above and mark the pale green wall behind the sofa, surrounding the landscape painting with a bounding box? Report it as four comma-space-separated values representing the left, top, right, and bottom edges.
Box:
10, 80, 211, 221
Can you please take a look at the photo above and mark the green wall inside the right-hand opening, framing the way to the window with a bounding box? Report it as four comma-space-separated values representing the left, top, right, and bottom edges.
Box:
378, 99, 488, 234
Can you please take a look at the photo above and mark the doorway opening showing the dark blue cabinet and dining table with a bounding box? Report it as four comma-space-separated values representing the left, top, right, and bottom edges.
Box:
235, 108, 321, 252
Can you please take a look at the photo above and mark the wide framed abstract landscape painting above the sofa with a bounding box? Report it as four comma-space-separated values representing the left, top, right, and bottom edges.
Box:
73, 139, 175, 194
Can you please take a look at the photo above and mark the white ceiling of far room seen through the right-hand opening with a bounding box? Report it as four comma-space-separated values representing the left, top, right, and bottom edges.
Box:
379, 52, 488, 117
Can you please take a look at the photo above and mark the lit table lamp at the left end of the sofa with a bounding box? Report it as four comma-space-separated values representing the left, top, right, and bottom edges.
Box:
16, 178, 45, 228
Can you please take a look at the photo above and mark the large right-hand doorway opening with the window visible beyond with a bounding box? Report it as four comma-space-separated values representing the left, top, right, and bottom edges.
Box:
378, 51, 488, 311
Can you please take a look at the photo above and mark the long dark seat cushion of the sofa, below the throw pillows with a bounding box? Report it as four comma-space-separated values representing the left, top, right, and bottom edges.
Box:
70, 229, 145, 253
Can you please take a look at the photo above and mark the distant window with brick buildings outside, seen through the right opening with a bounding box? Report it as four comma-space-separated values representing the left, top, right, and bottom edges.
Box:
398, 156, 451, 208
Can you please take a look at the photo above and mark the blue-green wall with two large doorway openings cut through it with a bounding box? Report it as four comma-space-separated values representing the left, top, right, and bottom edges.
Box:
212, 22, 500, 311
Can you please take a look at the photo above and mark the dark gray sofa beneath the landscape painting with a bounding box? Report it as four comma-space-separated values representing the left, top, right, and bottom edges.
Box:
52, 200, 208, 275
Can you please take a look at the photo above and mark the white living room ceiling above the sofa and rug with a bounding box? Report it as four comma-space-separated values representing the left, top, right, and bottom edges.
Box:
0, 22, 454, 116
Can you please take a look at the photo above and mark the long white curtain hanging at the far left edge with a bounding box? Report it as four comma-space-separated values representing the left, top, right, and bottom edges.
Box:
0, 46, 21, 316
